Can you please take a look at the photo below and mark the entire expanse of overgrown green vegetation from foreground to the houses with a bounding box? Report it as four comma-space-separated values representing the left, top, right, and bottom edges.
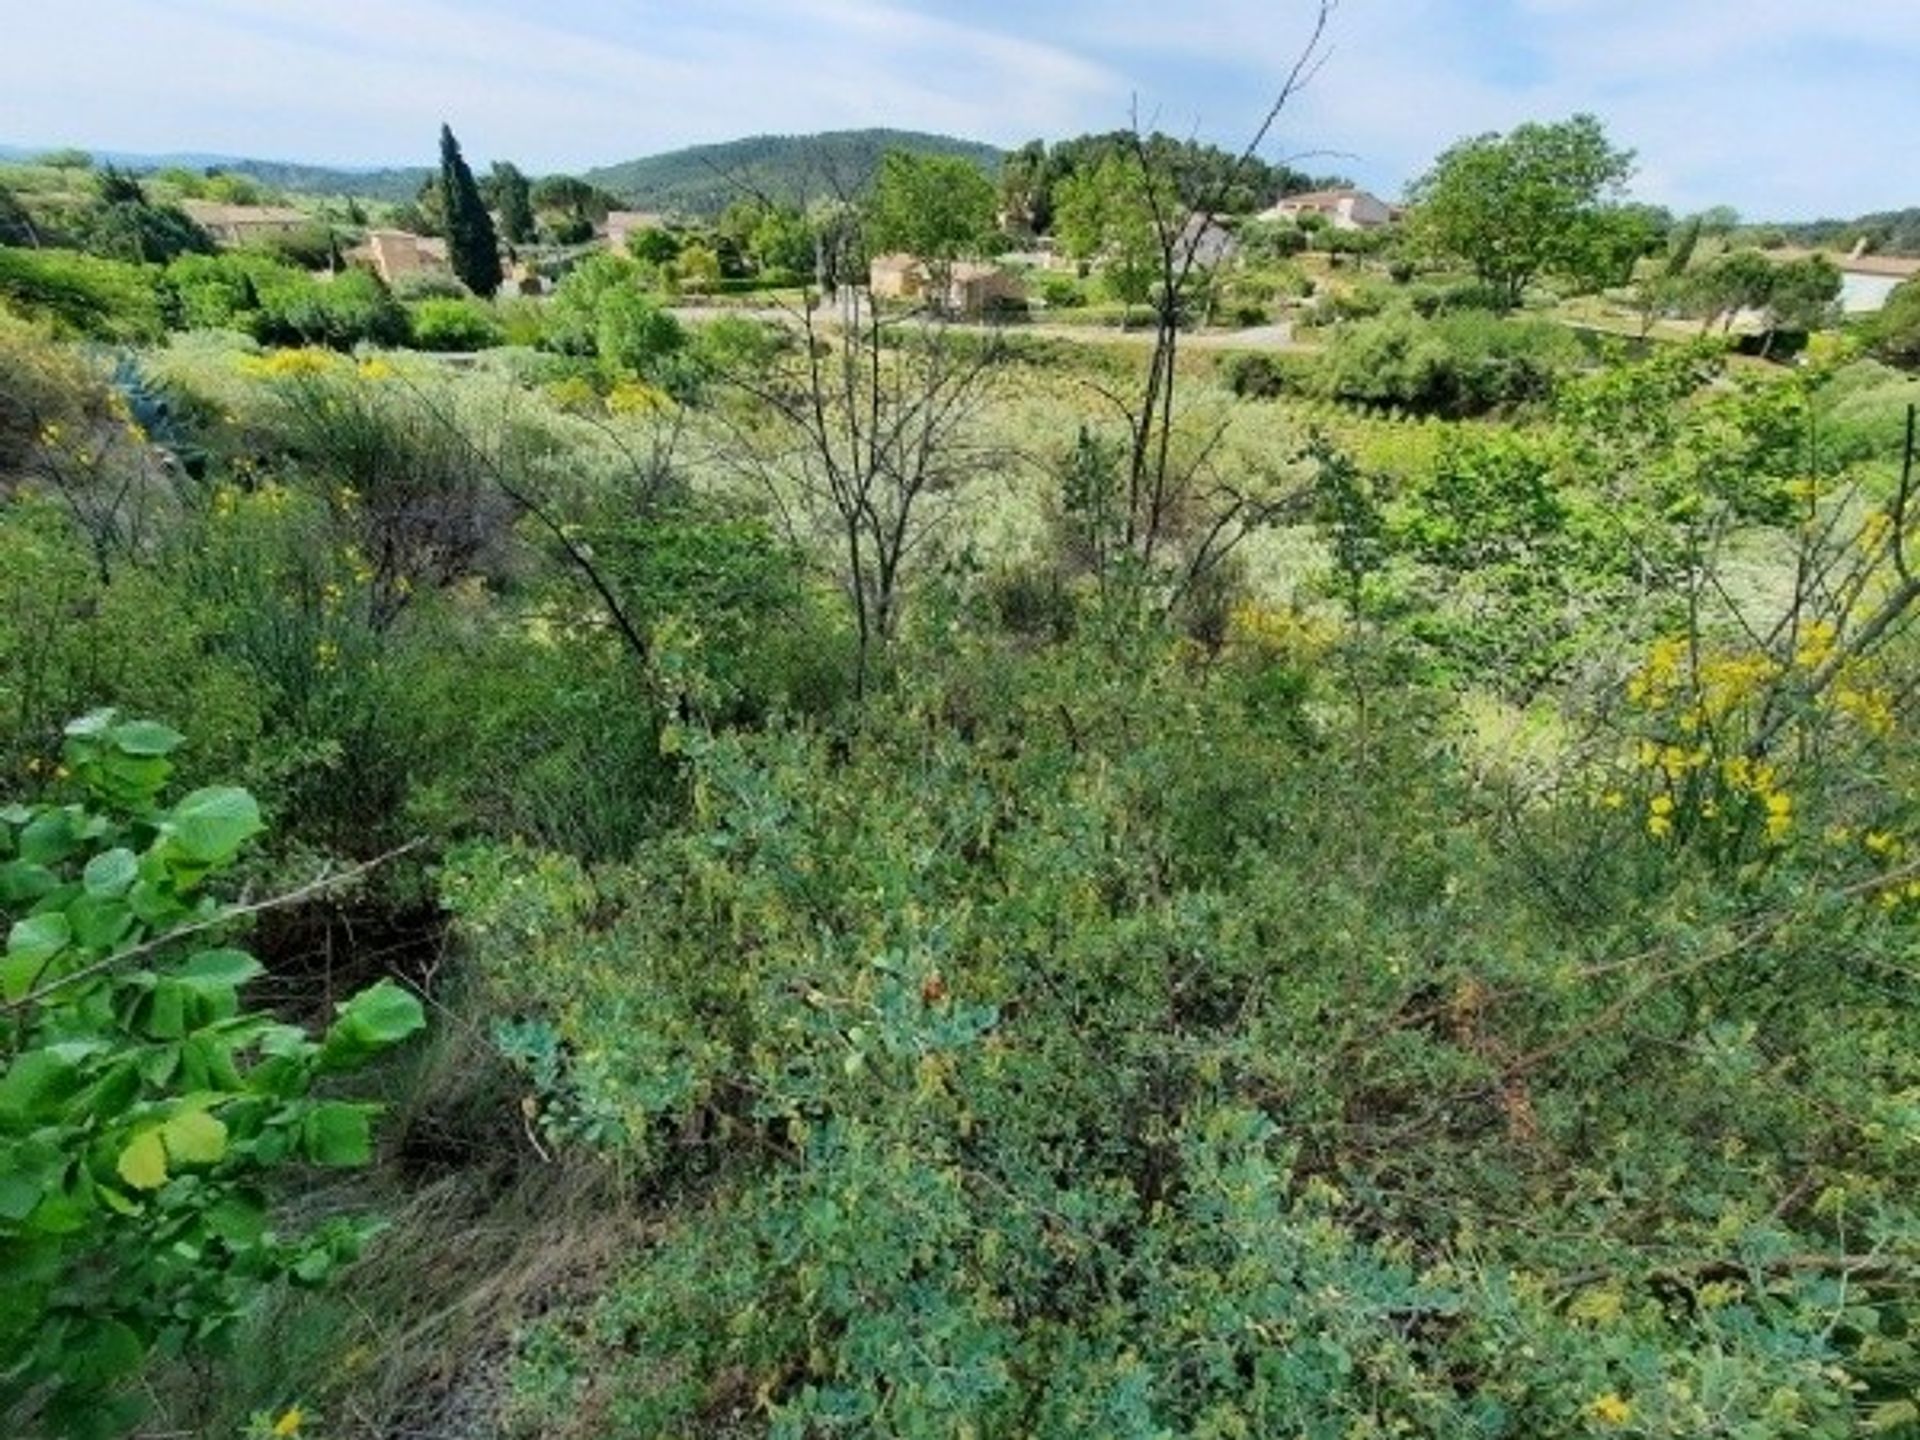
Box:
0, 93, 1920, 1440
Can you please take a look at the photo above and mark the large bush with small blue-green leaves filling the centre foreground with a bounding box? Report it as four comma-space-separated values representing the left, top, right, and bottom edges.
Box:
447, 616, 1914, 1440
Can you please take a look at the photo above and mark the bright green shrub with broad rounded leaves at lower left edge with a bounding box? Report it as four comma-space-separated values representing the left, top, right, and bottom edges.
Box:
0, 710, 424, 1438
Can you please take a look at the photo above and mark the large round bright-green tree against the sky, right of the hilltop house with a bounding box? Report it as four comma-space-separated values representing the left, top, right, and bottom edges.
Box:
1411, 115, 1634, 305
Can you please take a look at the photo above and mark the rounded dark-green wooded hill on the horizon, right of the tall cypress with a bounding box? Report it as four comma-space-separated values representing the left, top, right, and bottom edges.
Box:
584, 129, 1002, 215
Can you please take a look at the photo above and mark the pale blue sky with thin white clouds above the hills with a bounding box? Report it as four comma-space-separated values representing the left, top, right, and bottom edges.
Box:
0, 0, 1920, 219
